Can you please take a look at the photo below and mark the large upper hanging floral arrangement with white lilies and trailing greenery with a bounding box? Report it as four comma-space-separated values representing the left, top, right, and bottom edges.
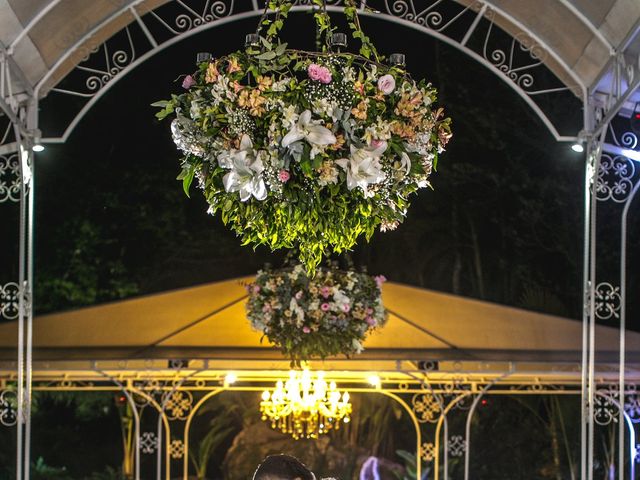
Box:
154, 0, 451, 272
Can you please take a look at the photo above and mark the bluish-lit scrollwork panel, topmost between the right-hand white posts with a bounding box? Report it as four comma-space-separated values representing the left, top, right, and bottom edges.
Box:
596, 153, 636, 203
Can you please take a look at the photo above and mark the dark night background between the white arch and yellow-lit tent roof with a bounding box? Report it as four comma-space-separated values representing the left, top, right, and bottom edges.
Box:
20, 10, 638, 326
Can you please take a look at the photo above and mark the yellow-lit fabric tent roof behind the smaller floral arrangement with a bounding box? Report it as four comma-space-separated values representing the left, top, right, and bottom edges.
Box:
0, 279, 640, 370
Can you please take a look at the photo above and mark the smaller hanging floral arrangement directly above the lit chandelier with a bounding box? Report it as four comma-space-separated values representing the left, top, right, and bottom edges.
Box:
246, 265, 387, 364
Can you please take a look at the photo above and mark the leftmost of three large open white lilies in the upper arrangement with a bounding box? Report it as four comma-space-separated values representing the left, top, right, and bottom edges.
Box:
218, 135, 267, 202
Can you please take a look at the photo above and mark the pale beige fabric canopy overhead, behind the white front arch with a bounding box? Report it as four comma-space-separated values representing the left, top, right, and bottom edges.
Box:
0, 0, 640, 100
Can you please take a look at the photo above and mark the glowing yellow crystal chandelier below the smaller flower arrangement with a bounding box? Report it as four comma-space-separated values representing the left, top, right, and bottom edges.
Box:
260, 368, 351, 440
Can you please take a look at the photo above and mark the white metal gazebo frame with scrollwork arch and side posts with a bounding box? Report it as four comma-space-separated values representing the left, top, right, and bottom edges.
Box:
0, 0, 640, 480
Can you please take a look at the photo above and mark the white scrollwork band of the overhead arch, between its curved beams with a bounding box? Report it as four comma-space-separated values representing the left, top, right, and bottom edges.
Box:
33, 0, 582, 153
